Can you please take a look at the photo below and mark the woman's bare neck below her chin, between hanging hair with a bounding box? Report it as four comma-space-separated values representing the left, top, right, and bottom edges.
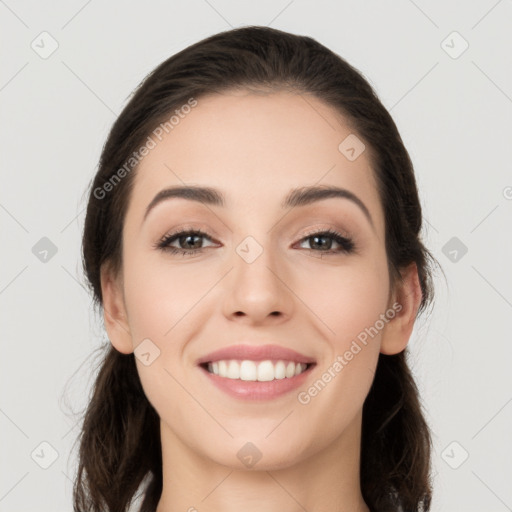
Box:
156, 414, 369, 512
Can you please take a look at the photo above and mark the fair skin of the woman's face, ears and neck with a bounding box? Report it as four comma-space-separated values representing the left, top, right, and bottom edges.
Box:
102, 91, 421, 512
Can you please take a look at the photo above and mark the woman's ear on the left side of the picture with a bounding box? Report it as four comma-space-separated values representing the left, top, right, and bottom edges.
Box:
100, 263, 134, 354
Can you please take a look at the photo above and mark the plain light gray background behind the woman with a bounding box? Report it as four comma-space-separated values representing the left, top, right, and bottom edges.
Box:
0, 0, 512, 512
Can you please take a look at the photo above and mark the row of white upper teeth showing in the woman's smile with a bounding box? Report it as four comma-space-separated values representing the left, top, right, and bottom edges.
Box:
208, 360, 307, 382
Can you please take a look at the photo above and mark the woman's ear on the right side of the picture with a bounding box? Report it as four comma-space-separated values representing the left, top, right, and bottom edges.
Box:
380, 263, 422, 355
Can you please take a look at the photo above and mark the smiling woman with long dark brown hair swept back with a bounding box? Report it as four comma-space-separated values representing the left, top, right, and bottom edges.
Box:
74, 27, 433, 512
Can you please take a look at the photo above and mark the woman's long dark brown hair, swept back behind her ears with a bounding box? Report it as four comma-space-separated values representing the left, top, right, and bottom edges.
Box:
74, 26, 435, 512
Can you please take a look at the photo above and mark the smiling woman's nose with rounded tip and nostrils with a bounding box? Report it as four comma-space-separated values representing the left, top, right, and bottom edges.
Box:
223, 240, 294, 325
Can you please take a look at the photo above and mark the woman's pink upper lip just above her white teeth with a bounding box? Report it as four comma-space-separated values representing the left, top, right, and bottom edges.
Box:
196, 344, 315, 365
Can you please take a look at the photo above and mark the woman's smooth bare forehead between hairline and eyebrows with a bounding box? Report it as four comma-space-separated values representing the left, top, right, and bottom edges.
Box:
127, 91, 382, 232
